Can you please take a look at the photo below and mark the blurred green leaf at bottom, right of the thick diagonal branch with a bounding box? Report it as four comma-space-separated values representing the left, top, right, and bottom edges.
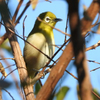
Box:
56, 86, 69, 100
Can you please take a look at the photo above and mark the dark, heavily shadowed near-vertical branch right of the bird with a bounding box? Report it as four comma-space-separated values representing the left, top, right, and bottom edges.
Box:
68, 0, 92, 100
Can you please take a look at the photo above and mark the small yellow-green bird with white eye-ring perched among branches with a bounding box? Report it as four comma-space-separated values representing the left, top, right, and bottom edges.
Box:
24, 12, 61, 78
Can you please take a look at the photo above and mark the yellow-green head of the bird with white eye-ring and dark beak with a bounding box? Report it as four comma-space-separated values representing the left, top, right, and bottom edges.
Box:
34, 12, 62, 31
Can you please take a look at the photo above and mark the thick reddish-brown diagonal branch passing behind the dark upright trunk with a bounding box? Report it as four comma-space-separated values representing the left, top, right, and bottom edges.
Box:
36, 2, 99, 100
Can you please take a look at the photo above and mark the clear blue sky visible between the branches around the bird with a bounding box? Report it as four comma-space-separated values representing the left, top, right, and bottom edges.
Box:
0, 0, 100, 100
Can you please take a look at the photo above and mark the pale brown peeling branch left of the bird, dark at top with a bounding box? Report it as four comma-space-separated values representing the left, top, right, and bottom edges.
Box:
0, 0, 34, 100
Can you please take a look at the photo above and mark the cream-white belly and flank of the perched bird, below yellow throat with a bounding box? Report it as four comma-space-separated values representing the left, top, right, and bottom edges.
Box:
24, 33, 53, 76
